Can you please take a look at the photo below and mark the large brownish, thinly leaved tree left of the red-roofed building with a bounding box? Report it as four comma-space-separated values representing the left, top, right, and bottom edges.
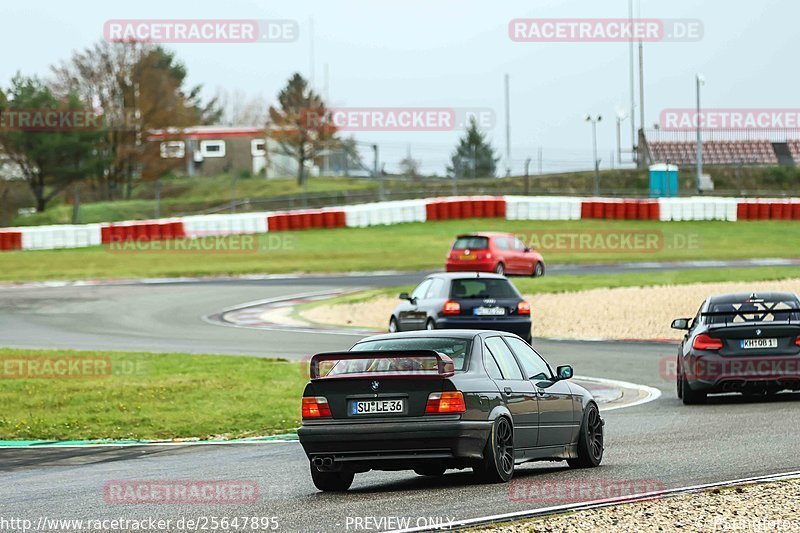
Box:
52, 41, 222, 200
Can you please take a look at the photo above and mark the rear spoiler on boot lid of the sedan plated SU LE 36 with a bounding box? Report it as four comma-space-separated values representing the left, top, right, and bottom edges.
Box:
310, 350, 455, 380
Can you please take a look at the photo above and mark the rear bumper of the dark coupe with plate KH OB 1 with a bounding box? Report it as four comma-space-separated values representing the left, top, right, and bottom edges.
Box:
685, 355, 800, 392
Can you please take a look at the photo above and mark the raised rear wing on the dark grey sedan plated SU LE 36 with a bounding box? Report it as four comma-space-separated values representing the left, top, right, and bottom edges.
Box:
310, 350, 455, 380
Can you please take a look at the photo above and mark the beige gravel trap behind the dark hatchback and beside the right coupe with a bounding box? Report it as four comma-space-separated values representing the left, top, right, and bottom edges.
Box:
301, 279, 800, 340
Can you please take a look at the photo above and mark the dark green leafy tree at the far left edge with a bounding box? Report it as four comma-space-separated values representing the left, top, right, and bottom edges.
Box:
0, 74, 106, 212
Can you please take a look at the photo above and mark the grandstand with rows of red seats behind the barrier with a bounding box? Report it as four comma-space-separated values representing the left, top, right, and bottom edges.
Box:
639, 130, 800, 166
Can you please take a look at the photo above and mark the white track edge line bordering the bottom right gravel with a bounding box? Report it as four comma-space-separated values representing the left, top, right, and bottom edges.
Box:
392, 471, 800, 533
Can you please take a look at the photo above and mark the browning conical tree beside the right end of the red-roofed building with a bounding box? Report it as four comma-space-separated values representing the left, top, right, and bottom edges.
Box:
267, 74, 336, 185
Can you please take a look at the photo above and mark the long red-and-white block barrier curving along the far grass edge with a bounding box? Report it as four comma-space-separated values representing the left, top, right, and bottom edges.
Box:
0, 196, 800, 251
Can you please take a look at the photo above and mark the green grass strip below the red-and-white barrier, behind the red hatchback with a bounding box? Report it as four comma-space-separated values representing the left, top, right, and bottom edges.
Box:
0, 219, 800, 281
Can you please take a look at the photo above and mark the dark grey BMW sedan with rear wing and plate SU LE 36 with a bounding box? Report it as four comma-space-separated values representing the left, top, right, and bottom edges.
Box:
298, 330, 603, 491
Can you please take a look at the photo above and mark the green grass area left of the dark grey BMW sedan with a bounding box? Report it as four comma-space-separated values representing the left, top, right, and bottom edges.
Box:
0, 349, 306, 440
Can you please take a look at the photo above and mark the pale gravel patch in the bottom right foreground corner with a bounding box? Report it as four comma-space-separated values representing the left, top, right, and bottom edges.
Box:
481, 480, 800, 533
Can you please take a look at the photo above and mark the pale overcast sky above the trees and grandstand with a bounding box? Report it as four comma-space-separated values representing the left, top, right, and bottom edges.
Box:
0, 0, 800, 173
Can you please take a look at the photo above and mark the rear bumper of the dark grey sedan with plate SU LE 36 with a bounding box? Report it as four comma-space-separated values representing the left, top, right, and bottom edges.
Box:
297, 417, 492, 469
